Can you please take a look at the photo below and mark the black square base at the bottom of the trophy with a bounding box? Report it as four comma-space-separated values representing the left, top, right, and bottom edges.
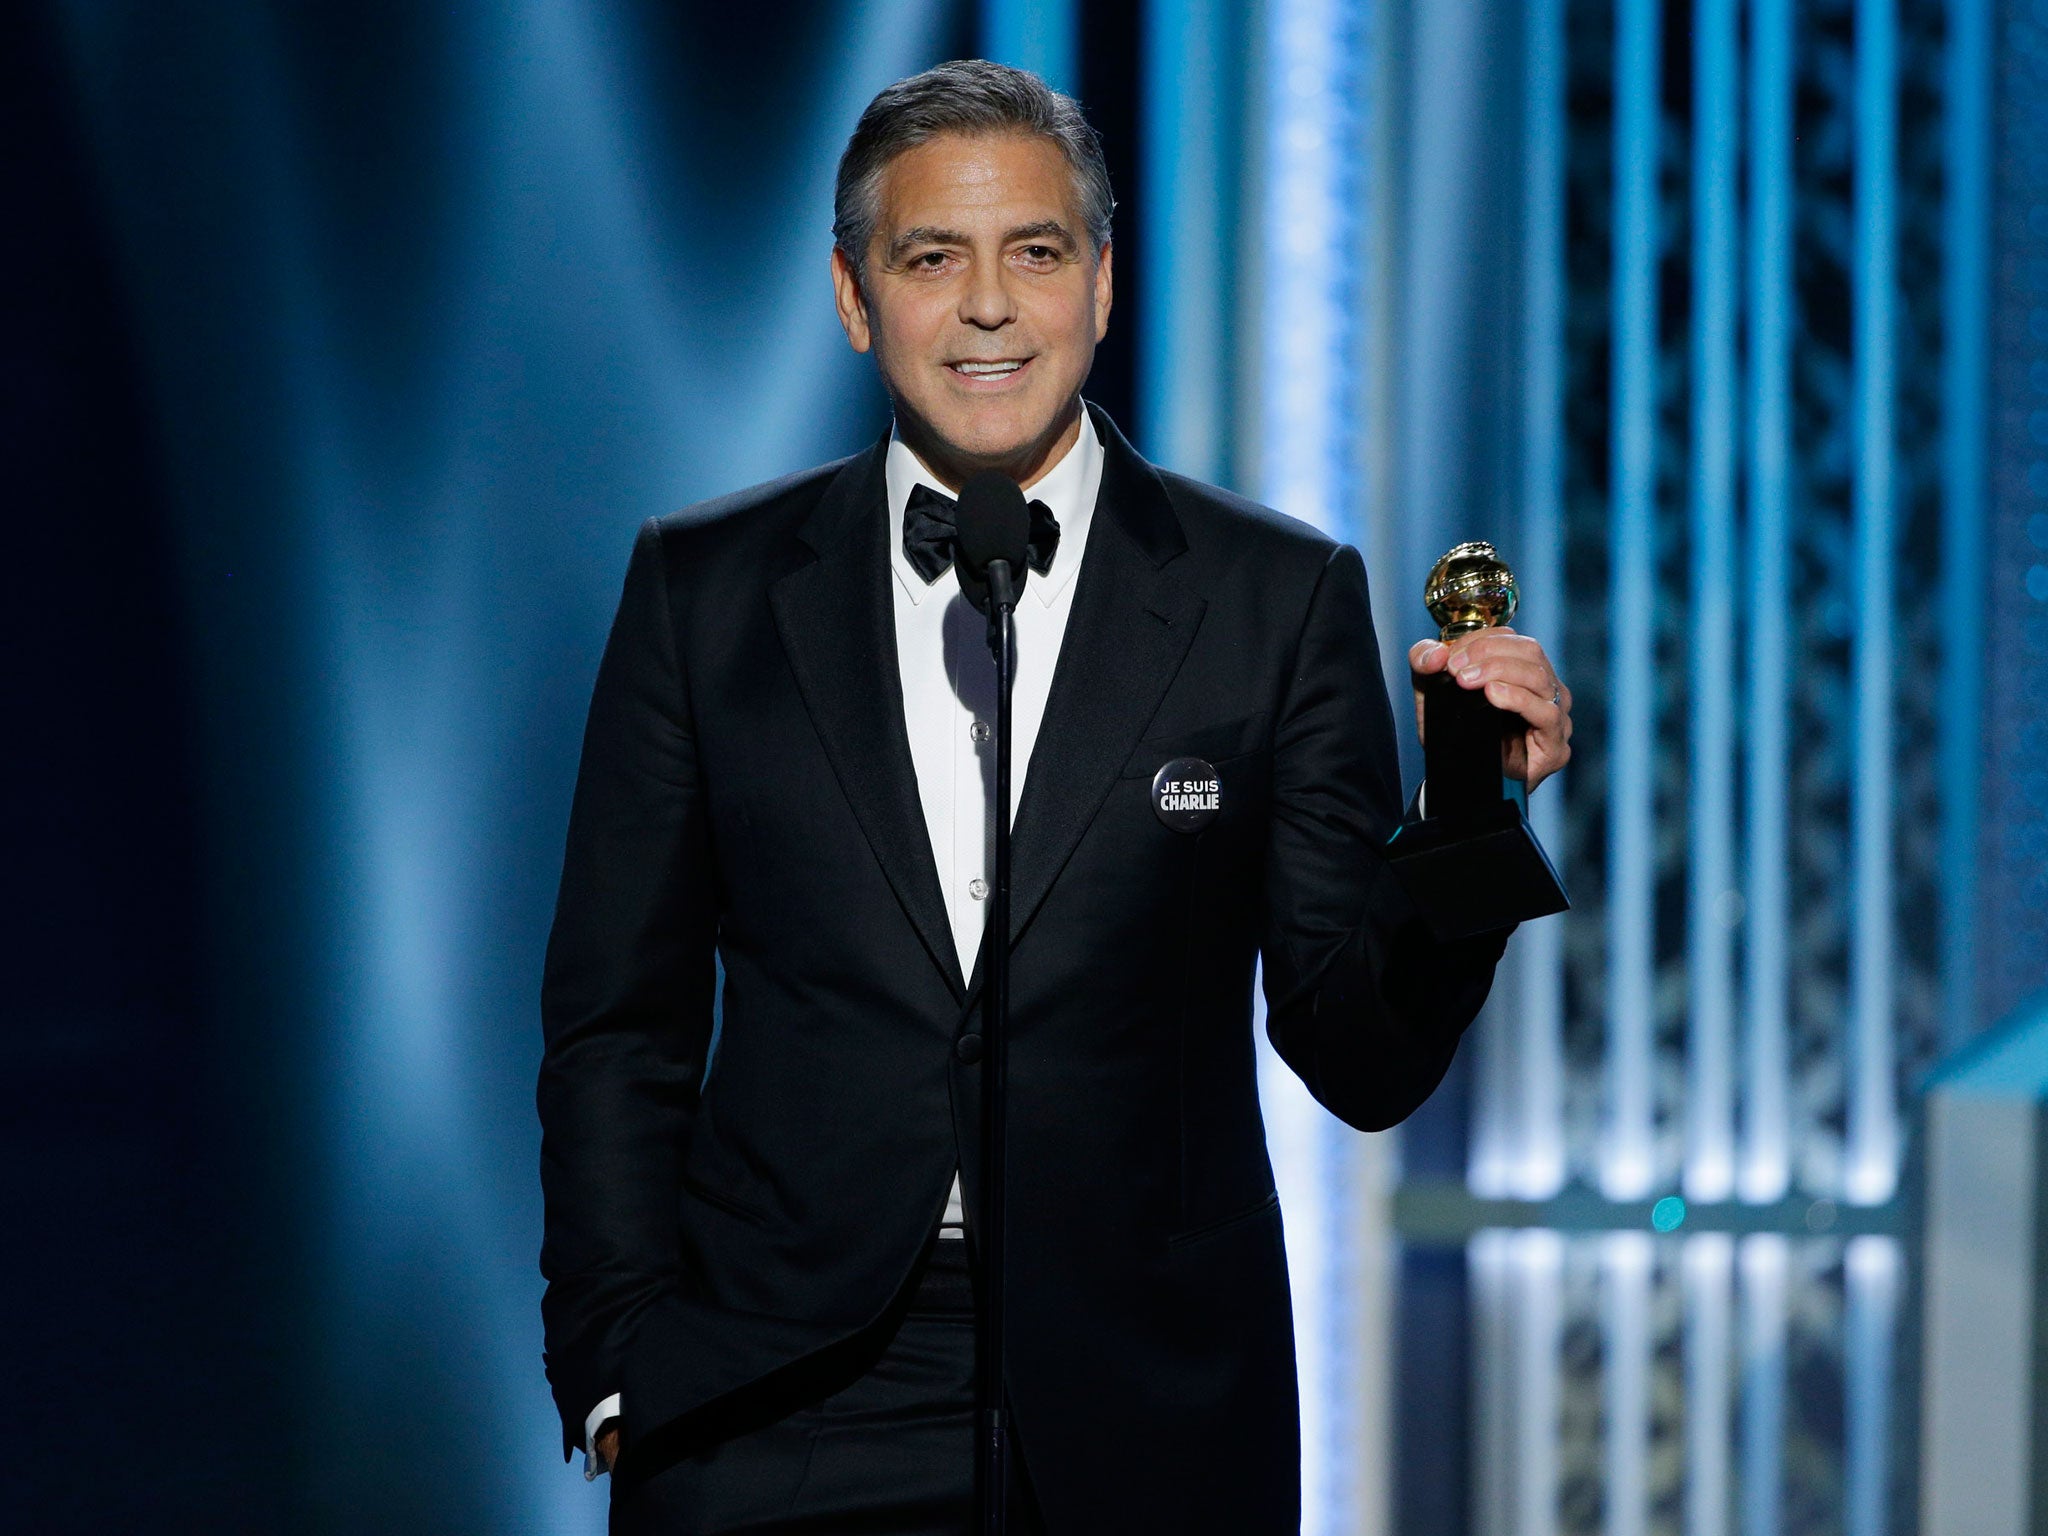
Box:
1386, 799, 1571, 940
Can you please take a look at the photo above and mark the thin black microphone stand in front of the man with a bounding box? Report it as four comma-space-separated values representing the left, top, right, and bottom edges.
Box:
975, 559, 1018, 1536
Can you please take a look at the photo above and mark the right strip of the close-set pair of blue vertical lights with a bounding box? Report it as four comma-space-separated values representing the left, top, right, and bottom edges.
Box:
1741, 0, 1792, 1202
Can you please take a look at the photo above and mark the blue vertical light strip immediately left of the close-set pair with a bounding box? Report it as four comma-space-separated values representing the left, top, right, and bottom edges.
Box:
1599, 0, 1661, 1200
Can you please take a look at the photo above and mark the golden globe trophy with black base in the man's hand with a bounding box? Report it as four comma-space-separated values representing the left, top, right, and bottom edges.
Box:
1386, 543, 1571, 938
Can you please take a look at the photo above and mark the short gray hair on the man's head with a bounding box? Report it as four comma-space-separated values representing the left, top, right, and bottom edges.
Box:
831, 59, 1116, 279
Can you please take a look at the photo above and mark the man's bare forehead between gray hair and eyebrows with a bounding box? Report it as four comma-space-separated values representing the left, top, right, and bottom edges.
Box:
877, 133, 1077, 240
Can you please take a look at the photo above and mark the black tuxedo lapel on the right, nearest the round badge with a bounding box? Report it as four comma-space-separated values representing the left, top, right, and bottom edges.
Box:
973, 406, 1206, 989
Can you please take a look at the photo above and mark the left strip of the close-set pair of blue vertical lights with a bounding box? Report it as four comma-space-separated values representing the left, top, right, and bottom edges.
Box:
1687, 0, 1741, 1200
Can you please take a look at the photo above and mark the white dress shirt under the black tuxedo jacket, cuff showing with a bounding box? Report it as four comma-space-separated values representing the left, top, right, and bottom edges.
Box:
584, 410, 1102, 1477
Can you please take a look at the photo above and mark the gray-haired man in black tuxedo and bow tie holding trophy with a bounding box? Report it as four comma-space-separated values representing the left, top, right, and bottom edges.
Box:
539, 61, 1571, 1534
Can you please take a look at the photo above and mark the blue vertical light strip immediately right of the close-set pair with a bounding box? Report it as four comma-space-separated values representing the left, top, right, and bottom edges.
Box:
1843, 0, 1898, 1204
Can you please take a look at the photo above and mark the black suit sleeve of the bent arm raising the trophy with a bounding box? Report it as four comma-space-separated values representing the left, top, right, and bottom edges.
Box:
1262, 547, 1507, 1130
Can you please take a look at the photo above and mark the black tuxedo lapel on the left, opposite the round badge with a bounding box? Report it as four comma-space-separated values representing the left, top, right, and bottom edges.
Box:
768, 438, 965, 995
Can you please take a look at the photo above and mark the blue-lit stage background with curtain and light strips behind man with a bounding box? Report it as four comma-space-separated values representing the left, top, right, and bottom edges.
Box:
0, 0, 2048, 1536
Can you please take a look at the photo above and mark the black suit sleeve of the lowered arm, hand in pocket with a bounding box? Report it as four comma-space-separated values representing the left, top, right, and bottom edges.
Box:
537, 522, 717, 1456
